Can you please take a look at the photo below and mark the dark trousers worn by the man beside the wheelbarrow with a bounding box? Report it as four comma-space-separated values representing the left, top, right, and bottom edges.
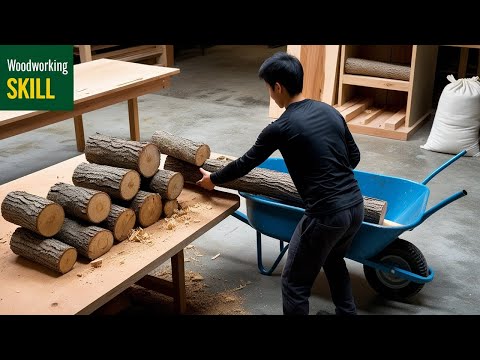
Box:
282, 202, 364, 315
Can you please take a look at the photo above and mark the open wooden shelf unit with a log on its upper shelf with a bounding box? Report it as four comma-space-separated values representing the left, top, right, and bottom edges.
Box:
336, 45, 438, 140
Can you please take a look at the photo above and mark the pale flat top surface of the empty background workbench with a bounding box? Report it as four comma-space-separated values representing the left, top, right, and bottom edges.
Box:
0, 59, 180, 124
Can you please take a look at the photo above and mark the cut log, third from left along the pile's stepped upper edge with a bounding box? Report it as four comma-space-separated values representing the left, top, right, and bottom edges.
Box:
72, 162, 140, 200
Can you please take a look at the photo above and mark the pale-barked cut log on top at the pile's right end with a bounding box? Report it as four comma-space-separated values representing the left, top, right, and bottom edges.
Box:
151, 130, 210, 166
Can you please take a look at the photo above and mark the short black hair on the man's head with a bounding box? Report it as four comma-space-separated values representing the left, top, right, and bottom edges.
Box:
258, 52, 303, 96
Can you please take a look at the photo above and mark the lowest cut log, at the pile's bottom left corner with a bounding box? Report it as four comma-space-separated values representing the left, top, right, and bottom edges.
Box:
10, 227, 77, 274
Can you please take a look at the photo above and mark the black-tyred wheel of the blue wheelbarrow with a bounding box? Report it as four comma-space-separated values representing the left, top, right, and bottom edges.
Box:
363, 239, 428, 300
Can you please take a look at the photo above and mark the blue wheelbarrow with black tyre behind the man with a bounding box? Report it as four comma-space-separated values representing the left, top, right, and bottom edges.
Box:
233, 151, 467, 300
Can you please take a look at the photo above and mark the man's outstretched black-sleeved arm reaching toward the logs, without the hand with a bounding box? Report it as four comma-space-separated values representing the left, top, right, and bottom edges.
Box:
210, 123, 280, 185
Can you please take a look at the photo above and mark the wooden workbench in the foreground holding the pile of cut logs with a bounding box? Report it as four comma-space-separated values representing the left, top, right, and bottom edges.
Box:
0, 155, 240, 314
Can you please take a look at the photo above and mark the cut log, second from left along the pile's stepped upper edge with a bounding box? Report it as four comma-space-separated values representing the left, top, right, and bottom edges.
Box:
47, 182, 112, 224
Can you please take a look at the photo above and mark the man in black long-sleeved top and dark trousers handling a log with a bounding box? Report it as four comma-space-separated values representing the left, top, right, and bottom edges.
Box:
197, 52, 364, 315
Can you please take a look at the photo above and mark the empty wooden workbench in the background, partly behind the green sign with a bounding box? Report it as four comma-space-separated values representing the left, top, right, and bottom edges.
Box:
0, 59, 180, 152
